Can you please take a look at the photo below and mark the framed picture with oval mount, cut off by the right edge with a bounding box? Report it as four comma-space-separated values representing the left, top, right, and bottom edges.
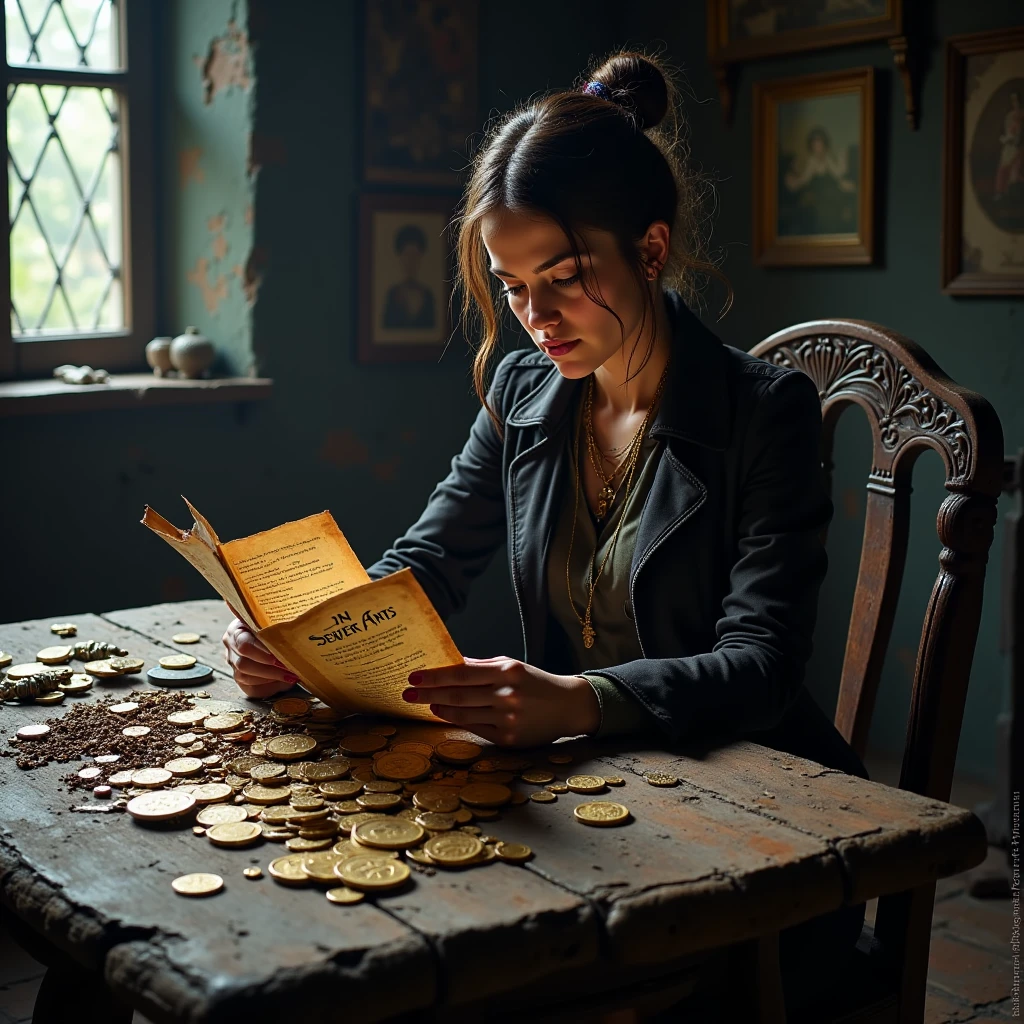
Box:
942, 28, 1024, 295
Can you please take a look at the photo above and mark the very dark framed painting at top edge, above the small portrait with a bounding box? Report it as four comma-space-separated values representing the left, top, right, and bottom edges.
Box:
362, 0, 479, 187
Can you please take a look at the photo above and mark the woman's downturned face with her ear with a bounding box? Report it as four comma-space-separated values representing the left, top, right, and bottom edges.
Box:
482, 211, 650, 380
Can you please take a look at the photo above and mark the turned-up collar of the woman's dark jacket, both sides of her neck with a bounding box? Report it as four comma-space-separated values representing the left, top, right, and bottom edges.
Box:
507, 290, 731, 452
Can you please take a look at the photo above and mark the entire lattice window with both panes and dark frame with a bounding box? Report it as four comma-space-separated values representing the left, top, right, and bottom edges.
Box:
0, 0, 155, 378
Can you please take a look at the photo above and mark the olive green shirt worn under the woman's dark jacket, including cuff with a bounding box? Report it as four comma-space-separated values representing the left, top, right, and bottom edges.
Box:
547, 407, 659, 736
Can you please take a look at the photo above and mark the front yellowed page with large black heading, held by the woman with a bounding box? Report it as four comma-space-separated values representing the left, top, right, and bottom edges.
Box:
259, 569, 463, 722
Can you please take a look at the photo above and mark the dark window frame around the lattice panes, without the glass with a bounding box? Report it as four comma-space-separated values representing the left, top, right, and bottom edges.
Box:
0, 0, 157, 380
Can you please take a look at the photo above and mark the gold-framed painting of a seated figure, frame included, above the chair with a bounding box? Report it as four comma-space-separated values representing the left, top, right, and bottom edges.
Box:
753, 68, 874, 266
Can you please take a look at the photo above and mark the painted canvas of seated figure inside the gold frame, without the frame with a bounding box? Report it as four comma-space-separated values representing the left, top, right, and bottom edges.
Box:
777, 92, 860, 239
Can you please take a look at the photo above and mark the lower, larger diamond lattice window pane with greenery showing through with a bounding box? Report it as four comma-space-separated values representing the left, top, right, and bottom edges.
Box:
7, 84, 125, 337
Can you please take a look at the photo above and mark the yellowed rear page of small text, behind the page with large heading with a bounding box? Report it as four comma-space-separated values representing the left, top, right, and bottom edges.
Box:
220, 512, 370, 629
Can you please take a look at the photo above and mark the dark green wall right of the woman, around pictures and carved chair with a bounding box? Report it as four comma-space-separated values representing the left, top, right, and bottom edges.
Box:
622, 0, 1024, 779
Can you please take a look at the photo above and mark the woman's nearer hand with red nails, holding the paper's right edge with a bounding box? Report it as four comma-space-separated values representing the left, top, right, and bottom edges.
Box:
402, 657, 601, 746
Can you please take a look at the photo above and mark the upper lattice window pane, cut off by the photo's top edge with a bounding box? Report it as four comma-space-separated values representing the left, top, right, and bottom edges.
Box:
4, 0, 121, 71
